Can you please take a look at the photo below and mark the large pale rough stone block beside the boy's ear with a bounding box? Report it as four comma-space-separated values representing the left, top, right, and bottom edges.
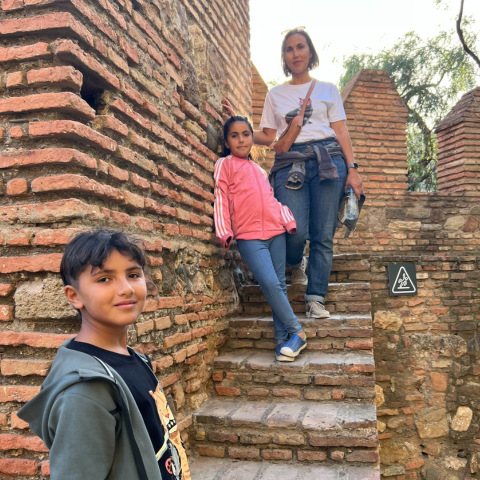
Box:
14, 277, 78, 320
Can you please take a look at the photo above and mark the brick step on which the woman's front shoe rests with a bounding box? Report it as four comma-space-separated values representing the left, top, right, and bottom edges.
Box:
226, 314, 373, 353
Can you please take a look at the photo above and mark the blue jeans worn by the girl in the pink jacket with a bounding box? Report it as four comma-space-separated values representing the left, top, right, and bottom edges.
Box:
237, 233, 302, 343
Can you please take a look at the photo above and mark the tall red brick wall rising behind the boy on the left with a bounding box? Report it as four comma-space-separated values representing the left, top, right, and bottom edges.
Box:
0, 0, 251, 478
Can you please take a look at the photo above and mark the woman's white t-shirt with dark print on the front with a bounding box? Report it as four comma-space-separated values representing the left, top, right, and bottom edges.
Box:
260, 80, 347, 143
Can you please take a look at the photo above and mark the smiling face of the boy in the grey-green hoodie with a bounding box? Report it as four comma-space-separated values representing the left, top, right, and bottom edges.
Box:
65, 250, 147, 329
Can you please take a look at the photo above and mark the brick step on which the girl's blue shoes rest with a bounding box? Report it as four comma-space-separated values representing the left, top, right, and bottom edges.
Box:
212, 350, 375, 404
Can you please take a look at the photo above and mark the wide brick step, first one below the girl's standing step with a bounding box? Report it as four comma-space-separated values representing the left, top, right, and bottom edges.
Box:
194, 399, 378, 464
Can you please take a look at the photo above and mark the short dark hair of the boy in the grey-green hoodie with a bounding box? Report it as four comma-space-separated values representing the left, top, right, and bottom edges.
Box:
60, 228, 145, 285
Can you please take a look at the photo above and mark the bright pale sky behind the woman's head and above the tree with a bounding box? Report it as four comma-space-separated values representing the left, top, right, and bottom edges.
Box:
250, 0, 480, 84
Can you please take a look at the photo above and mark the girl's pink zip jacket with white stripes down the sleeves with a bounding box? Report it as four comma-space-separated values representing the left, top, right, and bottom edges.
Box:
213, 155, 297, 250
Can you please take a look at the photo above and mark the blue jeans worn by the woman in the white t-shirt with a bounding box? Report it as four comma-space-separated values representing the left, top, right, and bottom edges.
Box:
274, 138, 347, 303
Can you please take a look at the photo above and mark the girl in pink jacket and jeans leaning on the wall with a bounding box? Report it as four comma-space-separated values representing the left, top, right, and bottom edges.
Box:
214, 116, 307, 361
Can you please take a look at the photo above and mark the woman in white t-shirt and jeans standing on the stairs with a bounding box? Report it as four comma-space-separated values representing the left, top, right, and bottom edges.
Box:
224, 27, 362, 318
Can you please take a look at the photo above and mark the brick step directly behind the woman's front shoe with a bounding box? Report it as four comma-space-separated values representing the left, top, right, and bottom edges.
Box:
239, 282, 372, 315
